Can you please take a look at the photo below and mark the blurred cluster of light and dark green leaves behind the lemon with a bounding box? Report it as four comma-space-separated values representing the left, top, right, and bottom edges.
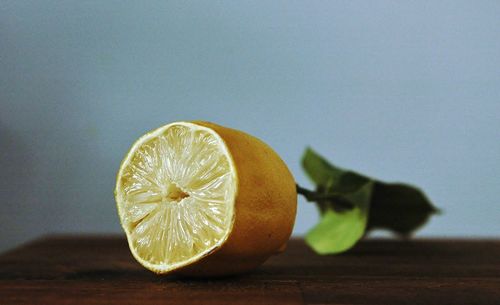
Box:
302, 148, 438, 254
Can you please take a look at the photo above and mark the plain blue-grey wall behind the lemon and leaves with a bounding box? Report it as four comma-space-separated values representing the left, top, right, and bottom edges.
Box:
0, 0, 500, 249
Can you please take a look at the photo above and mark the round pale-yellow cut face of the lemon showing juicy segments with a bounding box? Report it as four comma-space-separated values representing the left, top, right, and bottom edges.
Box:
115, 122, 237, 273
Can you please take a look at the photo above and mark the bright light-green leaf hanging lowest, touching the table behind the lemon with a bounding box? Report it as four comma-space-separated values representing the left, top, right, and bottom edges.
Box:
305, 182, 373, 255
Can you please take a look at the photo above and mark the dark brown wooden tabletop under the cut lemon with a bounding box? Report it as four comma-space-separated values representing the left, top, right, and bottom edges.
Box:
0, 236, 500, 305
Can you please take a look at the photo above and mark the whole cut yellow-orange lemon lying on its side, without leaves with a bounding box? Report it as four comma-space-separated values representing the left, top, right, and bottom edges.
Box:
115, 122, 297, 276
